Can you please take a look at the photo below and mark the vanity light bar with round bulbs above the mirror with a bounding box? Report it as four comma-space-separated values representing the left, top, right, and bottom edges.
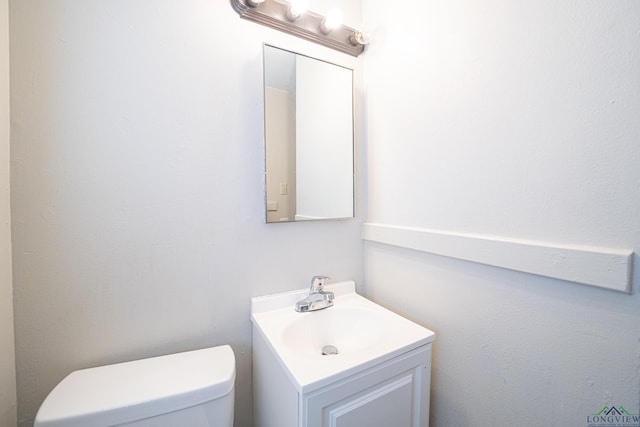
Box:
230, 0, 366, 56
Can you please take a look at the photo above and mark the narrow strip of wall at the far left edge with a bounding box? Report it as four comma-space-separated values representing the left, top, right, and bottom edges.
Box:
0, 0, 16, 427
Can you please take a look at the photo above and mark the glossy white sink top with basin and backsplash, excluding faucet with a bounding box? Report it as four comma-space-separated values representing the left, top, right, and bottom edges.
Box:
251, 281, 435, 392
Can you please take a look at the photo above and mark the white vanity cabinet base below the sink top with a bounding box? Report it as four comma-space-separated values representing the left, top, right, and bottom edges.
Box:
253, 330, 431, 427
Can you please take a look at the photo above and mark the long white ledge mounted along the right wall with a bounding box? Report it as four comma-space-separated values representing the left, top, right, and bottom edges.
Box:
362, 223, 633, 294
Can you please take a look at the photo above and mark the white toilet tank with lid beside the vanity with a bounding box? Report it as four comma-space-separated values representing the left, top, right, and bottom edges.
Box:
34, 345, 236, 427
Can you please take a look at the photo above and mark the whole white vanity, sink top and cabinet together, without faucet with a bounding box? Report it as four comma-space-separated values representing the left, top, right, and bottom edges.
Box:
251, 280, 435, 427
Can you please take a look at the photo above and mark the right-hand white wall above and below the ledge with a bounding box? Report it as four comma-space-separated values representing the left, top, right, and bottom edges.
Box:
363, 0, 640, 427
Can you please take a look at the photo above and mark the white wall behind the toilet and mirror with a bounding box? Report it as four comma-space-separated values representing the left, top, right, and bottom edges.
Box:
11, 0, 362, 427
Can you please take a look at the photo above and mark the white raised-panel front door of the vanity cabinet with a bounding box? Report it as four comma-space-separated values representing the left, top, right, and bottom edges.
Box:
300, 344, 431, 427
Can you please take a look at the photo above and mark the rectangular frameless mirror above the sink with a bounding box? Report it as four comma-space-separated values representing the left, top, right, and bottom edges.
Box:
264, 45, 354, 223
